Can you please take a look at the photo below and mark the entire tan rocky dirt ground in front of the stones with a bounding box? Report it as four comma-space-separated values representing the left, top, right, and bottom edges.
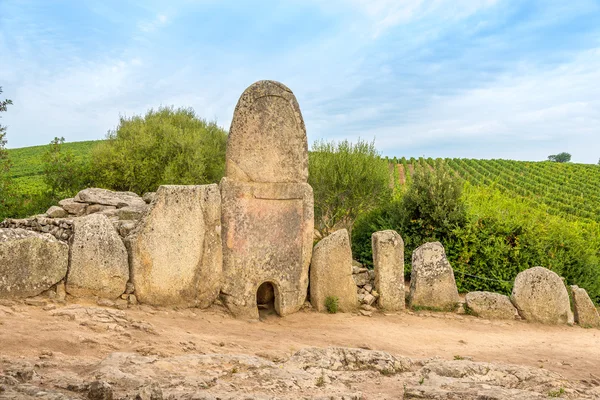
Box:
0, 300, 600, 400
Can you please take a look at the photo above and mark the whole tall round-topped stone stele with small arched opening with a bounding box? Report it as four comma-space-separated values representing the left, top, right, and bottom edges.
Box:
221, 81, 314, 318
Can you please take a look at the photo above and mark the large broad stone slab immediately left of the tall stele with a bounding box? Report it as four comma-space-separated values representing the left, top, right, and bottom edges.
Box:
128, 184, 223, 307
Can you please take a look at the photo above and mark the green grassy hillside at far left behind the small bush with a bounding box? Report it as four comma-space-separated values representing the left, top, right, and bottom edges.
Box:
8, 140, 100, 194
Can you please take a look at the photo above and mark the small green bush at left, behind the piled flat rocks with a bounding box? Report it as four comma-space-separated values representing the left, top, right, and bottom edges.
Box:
42, 137, 85, 199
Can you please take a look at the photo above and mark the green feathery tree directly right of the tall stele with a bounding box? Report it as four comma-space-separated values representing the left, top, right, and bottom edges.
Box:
308, 139, 392, 235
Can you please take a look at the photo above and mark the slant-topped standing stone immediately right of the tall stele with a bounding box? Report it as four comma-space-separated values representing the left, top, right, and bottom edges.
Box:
310, 229, 358, 312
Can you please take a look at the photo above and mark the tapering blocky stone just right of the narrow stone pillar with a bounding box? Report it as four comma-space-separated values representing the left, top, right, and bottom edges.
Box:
408, 242, 459, 310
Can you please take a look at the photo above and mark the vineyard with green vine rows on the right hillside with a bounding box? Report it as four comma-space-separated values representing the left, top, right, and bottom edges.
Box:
397, 158, 600, 222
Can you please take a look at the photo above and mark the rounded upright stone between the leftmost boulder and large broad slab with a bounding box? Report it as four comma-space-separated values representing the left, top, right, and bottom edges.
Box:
66, 214, 129, 299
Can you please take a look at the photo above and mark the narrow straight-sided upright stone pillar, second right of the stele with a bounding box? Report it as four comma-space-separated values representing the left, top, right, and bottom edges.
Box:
371, 230, 405, 311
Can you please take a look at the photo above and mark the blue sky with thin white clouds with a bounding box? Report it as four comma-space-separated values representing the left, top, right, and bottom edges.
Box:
0, 0, 600, 164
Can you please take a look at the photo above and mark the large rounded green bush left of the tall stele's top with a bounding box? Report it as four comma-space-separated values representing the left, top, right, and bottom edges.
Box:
90, 107, 227, 194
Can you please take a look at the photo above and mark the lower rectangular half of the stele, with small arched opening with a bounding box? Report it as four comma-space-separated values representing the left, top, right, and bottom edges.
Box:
221, 178, 314, 318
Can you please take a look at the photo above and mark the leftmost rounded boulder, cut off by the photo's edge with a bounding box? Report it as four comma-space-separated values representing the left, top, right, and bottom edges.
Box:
0, 229, 69, 298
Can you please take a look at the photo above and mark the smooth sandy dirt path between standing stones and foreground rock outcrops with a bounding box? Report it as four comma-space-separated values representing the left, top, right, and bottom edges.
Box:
0, 305, 600, 380
